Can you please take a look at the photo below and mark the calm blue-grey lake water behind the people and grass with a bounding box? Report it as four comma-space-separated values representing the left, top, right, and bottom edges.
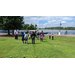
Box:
0, 29, 75, 35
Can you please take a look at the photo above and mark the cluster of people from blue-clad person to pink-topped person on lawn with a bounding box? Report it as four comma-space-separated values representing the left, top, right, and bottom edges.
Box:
22, 32, 44, 44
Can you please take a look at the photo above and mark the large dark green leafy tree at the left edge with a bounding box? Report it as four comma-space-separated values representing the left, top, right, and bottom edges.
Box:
0, 16, 24, 35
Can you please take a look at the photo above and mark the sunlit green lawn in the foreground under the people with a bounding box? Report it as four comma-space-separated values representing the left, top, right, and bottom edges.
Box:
0, 36, 75, 58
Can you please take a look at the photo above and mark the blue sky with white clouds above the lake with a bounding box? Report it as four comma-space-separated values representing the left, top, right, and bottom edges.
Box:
24, 16, 75, 28
